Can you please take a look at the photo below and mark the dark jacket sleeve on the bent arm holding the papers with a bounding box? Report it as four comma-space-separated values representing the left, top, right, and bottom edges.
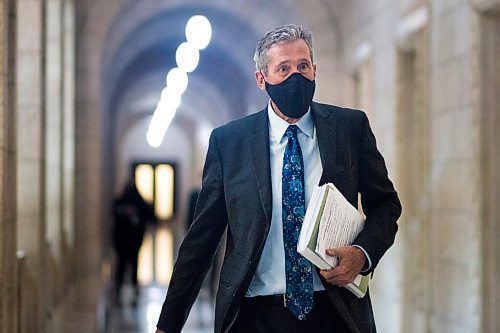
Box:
354, 113, 401, 273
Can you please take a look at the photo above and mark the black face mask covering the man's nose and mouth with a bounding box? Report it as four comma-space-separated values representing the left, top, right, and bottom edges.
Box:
264, 73, 316, 118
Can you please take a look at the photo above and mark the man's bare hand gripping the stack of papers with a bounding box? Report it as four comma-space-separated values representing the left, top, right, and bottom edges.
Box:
320, 246, 366, 286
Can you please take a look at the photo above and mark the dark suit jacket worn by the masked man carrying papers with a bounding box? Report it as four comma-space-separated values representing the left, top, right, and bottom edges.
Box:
158, 103, 401, 333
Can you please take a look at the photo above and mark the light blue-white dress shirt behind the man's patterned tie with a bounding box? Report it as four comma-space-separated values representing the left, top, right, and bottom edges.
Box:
246, 103, 324, 297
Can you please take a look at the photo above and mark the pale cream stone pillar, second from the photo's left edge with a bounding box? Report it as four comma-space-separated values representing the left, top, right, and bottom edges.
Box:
16, 0, 47, 332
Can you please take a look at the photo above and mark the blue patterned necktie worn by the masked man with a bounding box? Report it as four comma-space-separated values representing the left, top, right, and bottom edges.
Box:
282, 125, 314, 320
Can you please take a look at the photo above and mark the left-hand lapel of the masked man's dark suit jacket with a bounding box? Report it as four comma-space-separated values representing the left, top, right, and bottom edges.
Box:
250, 108, 272, 225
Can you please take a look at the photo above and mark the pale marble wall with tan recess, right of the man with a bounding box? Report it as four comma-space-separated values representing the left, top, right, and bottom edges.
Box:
328, 0, 498, 332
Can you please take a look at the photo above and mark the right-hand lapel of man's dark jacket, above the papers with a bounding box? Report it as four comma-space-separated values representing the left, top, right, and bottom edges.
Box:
311, 102, 337, 185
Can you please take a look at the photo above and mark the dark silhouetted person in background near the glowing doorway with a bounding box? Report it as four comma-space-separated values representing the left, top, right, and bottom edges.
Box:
113, 180, 155, 304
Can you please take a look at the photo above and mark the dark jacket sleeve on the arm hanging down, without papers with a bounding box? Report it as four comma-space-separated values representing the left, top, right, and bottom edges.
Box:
157, 132, 228, 333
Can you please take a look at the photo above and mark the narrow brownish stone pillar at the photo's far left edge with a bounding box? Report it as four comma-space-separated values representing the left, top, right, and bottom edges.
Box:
0, 0, 19, 332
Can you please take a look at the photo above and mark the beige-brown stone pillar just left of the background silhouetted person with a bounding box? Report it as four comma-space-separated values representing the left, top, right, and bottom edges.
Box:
74, 1, 105, 330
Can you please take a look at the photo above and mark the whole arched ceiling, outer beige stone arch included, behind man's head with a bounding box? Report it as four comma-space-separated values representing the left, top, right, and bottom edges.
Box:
77, 0, 338, 167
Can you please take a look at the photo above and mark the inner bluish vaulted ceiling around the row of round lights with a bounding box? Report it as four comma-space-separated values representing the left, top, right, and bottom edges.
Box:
102, 4, 286, 135
